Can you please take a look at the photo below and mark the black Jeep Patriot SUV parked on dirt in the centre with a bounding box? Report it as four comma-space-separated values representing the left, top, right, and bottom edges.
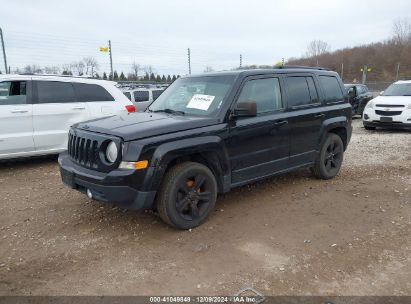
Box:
59, 67, 351, 229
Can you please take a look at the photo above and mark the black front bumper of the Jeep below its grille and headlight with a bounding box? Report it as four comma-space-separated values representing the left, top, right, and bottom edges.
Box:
58, 153, 156, 210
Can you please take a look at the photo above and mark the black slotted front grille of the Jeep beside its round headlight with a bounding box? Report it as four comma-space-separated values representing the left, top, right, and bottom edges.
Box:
68, 133, 99, 169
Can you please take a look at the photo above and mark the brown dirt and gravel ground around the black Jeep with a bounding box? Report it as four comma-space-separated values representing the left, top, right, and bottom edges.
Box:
0, 119, 411, 295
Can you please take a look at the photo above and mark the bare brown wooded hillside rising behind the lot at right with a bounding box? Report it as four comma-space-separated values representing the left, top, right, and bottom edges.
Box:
287, 19, 411, 82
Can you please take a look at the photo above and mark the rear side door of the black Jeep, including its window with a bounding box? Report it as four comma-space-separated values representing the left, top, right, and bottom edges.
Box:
285, 73, 325, 166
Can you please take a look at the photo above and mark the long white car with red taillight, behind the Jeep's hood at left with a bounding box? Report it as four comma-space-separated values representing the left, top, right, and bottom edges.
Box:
0, 75, 135, 159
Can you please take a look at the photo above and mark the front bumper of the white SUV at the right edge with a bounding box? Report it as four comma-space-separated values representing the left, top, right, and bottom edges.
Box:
362, 107, 411, 129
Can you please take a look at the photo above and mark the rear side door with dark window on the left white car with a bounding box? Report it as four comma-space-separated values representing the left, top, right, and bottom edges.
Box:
33, 80, 90, 152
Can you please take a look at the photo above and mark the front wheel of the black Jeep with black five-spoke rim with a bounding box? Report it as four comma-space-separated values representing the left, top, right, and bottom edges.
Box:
156, 162, 217, 229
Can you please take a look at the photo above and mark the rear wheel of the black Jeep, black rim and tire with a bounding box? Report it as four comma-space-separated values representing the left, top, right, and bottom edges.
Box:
312, 133, 344, 179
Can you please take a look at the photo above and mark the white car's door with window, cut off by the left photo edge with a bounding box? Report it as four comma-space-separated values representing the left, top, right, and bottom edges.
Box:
0, 81, 34, 158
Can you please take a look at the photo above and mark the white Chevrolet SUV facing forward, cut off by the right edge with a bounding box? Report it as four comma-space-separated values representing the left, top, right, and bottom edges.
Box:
362, 80, 411, 130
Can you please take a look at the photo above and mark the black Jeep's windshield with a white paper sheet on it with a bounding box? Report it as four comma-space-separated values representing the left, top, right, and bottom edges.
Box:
149, 76, 235, 116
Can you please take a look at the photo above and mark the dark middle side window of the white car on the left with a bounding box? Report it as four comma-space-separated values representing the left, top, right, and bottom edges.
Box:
36, 81, 76, 103
